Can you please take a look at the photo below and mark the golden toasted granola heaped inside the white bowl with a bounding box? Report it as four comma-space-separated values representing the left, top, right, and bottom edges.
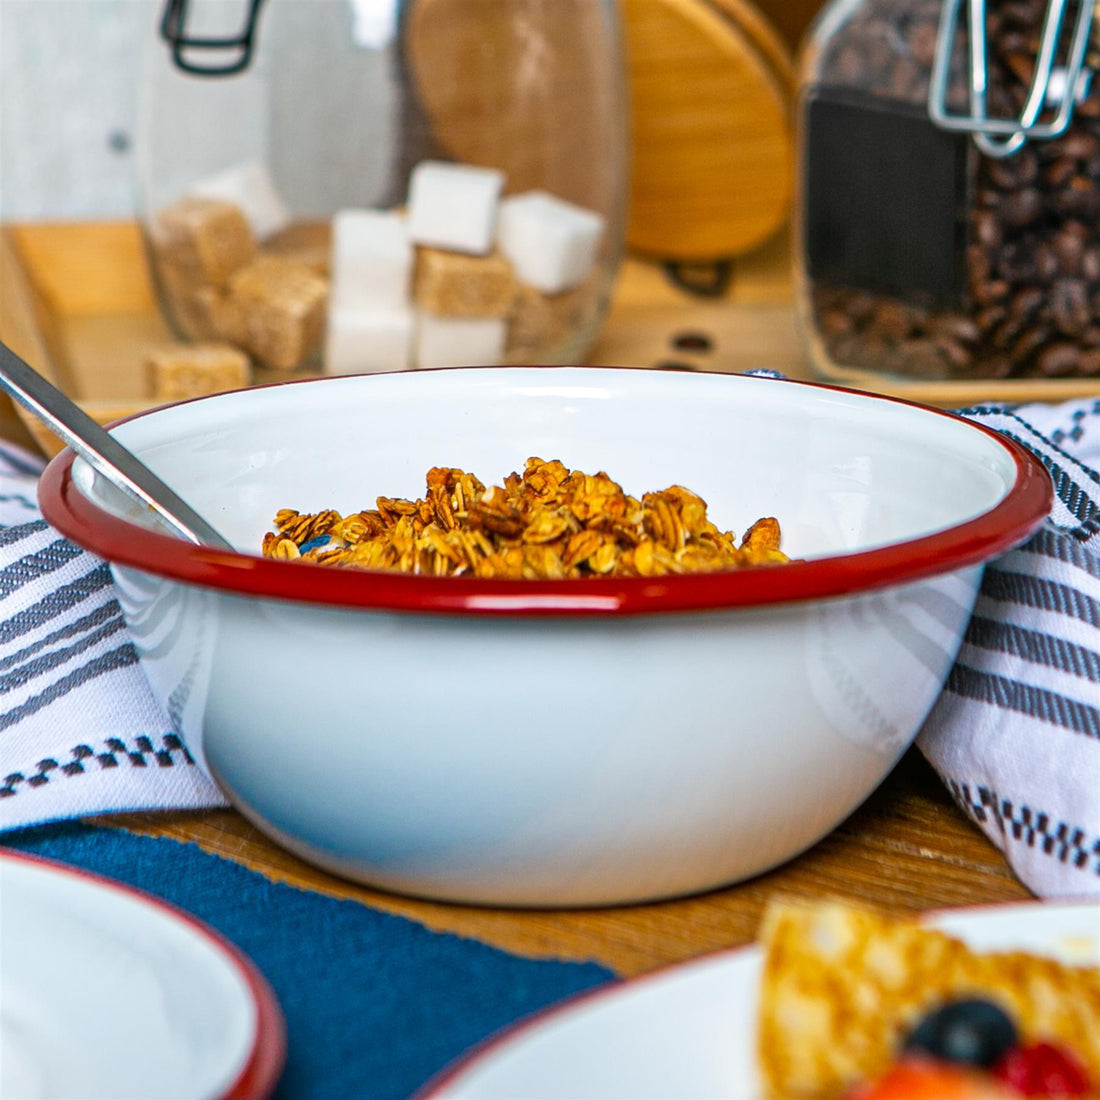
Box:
263, 458, 788, 580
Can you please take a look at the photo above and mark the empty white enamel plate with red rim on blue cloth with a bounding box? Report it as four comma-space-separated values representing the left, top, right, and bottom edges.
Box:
0, 853, 286, 1100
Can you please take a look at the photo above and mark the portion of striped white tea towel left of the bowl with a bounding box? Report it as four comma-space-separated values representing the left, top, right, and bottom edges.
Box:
0, 443, 226, 829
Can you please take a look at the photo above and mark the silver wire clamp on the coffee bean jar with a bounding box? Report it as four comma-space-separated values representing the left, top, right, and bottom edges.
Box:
928, 0, 1097, 157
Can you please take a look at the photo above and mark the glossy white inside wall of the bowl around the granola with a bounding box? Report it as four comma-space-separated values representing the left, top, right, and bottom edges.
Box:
74, 367, 1018, 559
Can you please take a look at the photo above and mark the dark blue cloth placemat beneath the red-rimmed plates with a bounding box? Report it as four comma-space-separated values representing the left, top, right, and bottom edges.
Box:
3, 822, 613, 1100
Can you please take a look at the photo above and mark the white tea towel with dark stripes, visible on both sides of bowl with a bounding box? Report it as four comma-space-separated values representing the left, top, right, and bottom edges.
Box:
0, 400, 1100, 897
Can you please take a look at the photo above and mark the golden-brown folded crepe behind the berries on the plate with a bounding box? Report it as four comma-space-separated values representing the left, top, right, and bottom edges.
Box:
757, 902, 1100, 1100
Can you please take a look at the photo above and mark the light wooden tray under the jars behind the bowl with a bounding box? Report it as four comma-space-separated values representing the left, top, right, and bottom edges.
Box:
0, 221, 1100, 454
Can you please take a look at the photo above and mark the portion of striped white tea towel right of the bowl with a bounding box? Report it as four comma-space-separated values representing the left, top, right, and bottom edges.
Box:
917, 399, 1100, 898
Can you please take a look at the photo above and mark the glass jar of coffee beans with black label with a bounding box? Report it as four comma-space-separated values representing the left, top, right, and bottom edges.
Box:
794, 0, 1100, 383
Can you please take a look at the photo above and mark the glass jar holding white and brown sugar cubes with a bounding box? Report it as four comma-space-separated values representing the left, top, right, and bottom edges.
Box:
138, 0, 626, 373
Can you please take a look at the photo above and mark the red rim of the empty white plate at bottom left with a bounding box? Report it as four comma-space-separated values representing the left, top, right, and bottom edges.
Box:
0, 850, 286, 1100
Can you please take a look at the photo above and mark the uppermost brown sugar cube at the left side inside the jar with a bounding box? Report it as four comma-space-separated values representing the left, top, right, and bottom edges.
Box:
150, 198, 256, 286
